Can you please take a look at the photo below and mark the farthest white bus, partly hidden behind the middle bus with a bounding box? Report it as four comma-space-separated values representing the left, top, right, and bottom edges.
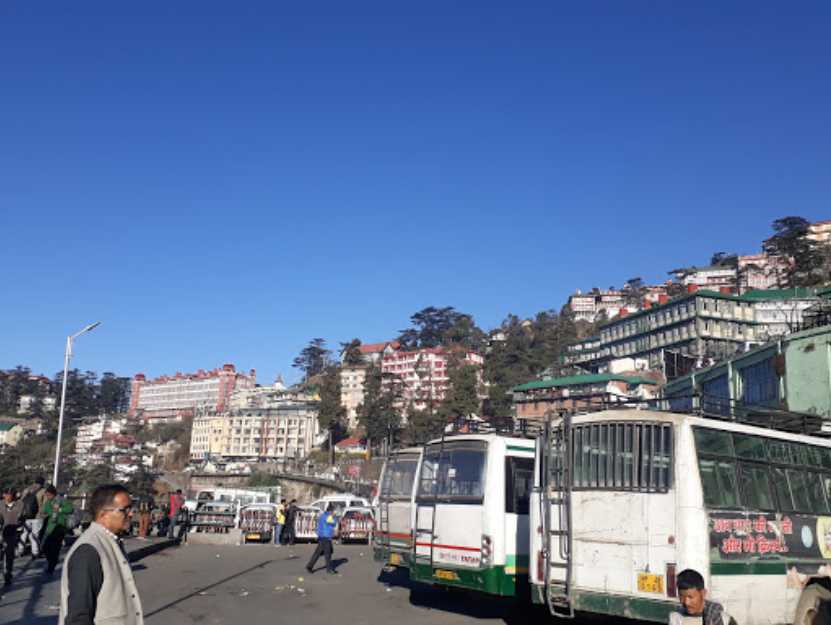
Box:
372, 447, 422, 568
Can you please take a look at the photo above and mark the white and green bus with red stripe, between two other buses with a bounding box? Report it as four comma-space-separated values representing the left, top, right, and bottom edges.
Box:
410, 433, 534, 596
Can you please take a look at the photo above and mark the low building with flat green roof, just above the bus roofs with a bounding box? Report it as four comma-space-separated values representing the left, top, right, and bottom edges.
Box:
513, 373, 658, 421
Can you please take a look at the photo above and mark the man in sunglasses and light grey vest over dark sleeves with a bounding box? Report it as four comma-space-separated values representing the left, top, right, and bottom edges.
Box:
59, 484, 144, 625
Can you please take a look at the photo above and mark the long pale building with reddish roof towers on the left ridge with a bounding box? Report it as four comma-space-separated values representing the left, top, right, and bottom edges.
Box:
128, 364, 257, 424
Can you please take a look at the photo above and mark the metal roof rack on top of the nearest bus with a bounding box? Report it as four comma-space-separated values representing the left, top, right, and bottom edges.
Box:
553, 393, 831, 438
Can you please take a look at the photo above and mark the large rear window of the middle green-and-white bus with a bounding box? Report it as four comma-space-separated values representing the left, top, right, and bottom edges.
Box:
418, 441, 487, 502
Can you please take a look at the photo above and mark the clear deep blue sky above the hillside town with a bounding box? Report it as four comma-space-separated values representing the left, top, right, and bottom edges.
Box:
0, 1, 831, 382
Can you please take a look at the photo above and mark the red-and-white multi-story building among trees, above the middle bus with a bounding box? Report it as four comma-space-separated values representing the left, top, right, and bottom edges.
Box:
381, 347, 485, 410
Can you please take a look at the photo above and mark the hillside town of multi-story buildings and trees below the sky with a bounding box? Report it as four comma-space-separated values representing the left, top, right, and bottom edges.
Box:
0, 221, 831, 481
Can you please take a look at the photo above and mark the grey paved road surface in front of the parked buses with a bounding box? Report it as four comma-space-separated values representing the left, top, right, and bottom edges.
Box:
0, 545, 636, 625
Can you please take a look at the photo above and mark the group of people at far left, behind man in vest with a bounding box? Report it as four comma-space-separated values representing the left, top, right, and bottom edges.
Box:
0, 477, 76, 586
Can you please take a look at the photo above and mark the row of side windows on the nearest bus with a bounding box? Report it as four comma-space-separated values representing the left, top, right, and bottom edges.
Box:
693, 427, 831, 515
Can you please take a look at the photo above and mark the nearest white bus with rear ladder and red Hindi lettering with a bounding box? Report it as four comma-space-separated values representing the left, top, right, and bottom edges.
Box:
530, 409, 831, 625
